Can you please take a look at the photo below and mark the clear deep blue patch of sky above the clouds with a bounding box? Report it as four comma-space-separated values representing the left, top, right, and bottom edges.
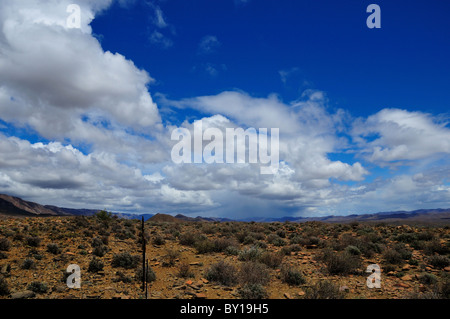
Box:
92, 0, 450, 116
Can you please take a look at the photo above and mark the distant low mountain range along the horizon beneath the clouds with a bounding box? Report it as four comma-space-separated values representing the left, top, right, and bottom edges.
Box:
0, 194, 450, 224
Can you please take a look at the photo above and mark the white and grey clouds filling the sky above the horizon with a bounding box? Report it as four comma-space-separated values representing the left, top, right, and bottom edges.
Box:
0, 0, 450, 217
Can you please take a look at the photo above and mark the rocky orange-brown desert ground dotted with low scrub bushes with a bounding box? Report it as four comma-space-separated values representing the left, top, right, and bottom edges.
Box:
0, 215, 450, 299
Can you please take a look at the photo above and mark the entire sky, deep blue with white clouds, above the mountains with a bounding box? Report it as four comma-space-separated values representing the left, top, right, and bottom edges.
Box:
0, 0, 450, 217
